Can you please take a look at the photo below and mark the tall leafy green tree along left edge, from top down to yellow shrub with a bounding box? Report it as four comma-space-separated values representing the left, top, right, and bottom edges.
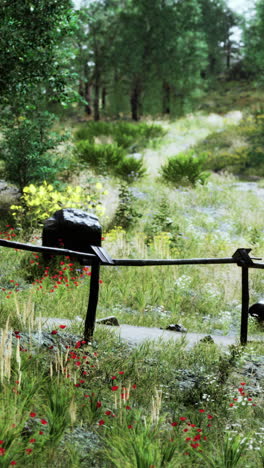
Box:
0, 0, 76, 191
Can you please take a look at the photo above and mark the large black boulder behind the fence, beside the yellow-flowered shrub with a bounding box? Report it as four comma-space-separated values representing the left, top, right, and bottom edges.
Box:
42, 208, 102, 253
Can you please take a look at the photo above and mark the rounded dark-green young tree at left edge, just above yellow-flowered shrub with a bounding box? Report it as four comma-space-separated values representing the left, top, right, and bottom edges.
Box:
0, 112, 70, 192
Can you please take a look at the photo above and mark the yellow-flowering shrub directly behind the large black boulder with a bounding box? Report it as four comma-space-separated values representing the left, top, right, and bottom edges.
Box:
10, 182, 103, 231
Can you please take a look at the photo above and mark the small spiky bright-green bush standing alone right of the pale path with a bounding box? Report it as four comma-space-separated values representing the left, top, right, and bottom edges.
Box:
161, 151, 209, 186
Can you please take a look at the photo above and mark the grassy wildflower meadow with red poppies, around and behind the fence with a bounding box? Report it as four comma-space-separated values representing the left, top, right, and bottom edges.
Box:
0, 82, 264, 468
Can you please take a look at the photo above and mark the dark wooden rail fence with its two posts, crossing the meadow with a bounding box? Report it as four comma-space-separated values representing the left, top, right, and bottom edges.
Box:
0, 239, 264, 345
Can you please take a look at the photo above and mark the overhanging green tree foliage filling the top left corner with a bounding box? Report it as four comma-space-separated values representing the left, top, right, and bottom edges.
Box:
0, 0, 73, 105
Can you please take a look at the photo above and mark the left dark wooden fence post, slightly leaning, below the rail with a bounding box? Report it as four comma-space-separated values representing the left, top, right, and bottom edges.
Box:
84, 261, 100, 341
